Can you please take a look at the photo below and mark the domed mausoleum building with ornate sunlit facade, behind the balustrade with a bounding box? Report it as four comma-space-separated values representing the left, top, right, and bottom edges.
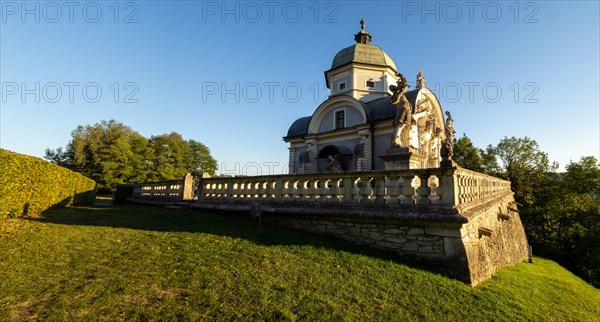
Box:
284, 20, 446, 174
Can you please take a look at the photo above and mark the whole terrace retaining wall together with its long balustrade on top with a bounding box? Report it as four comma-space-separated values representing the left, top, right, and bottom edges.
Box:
193, 167, 528, 285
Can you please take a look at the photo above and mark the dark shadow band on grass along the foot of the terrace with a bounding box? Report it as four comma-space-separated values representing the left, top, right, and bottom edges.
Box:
28, 205, 451, 277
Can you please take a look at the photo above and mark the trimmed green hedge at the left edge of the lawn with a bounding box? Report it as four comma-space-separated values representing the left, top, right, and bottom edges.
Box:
0, 149, 96, 220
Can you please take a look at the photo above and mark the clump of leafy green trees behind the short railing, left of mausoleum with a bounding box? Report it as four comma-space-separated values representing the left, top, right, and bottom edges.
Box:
45, 120, 216, 188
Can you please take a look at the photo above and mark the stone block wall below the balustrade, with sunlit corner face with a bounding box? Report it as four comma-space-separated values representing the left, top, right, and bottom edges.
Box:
262, 194, 528, 286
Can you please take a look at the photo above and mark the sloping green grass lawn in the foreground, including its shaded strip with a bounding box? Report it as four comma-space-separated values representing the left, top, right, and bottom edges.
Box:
0, 206, 600, 321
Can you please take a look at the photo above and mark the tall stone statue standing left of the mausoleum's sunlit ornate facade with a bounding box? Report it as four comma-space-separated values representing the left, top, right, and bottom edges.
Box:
390, 73, 413, 147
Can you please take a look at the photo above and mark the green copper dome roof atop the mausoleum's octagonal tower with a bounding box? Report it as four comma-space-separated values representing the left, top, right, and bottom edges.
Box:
331, 43, 397, 71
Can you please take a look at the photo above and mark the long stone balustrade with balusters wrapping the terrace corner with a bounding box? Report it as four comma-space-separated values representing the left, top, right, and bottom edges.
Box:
199, 168, 510, 207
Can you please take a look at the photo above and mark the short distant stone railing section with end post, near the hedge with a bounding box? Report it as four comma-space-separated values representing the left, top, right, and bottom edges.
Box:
132, 173, 194, 201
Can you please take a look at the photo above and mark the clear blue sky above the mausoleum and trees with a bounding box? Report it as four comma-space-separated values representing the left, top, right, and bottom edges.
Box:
0, 0, 600, 174
